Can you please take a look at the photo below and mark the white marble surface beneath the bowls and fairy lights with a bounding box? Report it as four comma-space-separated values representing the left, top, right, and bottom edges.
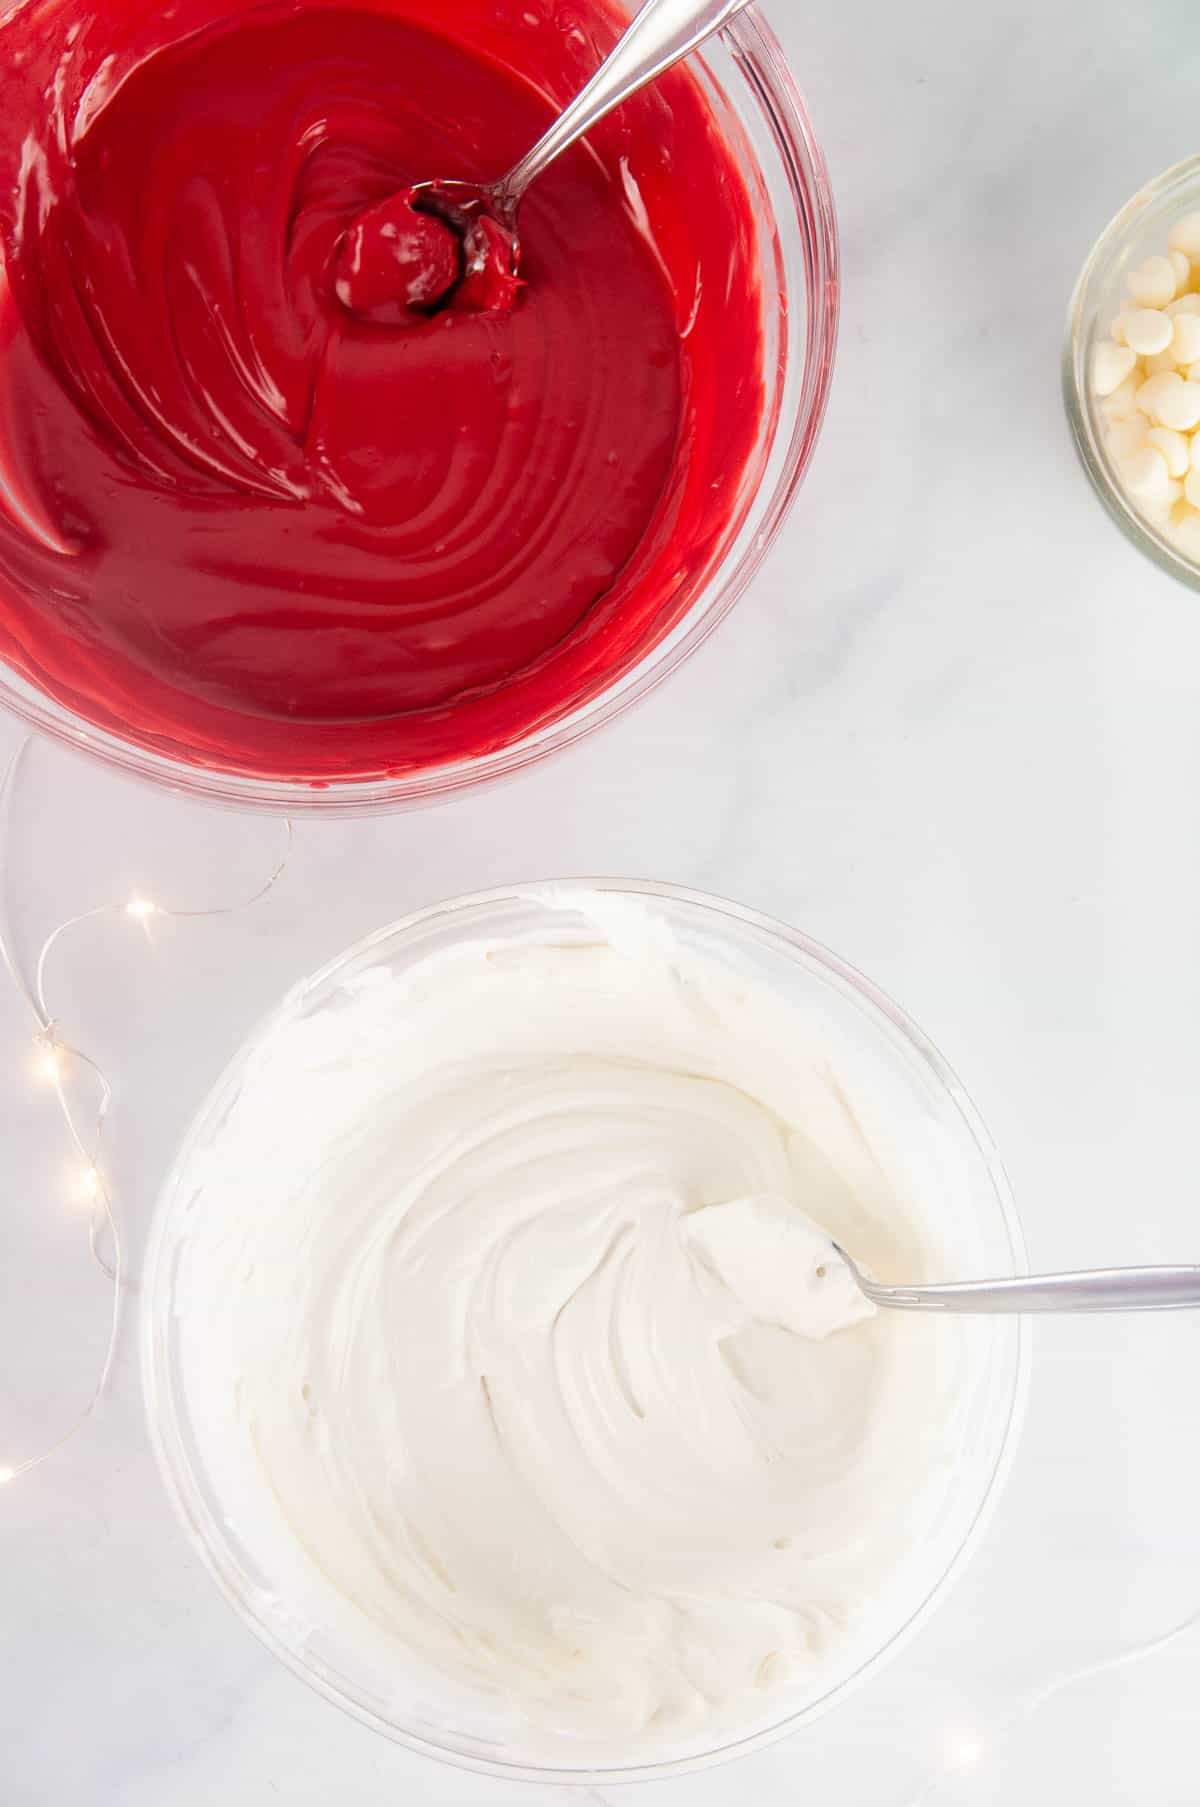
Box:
0, 0, 1200, 1807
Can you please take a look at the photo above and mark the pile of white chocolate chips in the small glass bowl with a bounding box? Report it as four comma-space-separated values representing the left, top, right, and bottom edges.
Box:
1092, 213, 1200, 562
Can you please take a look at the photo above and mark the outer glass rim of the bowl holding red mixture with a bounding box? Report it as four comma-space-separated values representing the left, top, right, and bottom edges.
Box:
0, 7, 839, 817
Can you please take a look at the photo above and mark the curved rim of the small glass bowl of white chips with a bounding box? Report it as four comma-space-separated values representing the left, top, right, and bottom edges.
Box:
1063, 152, 1200, 589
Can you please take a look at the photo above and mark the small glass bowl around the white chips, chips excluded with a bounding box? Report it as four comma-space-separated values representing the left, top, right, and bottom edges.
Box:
1063, 155, 1200, 589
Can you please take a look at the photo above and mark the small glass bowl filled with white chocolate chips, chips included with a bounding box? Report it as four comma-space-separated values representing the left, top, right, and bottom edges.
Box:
1063, 157, 1200, 587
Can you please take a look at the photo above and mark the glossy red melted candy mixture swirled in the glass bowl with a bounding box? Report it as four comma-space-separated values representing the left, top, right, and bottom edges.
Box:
0, 0, 763, 782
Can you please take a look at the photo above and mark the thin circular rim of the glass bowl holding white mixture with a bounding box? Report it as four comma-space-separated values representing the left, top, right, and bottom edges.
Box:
139, 876, 1030, 1787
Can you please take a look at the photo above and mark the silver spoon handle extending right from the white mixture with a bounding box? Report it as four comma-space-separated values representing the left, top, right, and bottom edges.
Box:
860, 1267, 1200, 1312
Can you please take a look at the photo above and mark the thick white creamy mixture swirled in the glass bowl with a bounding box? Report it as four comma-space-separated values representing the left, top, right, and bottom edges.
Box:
181, 905, 960, 1753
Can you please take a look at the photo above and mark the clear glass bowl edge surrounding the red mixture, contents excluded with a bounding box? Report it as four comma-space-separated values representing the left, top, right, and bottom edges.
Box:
0, 11, 839, 815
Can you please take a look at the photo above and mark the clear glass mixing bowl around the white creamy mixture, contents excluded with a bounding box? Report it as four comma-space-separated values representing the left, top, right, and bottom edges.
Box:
143, 880, 1027, 1784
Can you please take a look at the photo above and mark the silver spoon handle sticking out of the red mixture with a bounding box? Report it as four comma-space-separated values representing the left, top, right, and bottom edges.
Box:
497, 0, 750, 208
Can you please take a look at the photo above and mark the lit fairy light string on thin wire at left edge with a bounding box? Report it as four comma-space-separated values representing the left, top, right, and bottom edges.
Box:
0, 735, 293, 1485
